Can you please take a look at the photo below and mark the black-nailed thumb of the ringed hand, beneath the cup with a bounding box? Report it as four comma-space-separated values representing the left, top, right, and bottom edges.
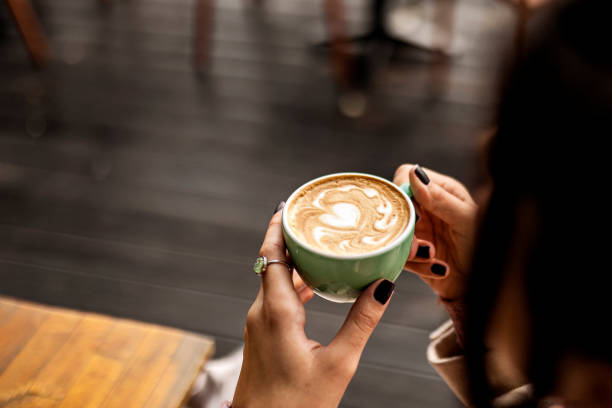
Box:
328, 279, 395, 362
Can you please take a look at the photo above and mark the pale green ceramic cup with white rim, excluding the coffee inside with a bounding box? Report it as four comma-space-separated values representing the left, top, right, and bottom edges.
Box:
282, 173, 416, 303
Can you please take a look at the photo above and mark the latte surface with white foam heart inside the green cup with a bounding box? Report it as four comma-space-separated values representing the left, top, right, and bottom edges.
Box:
287, 175, 410, 255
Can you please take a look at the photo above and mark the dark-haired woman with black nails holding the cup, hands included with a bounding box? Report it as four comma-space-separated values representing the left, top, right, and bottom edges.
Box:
232, 0, 612, 408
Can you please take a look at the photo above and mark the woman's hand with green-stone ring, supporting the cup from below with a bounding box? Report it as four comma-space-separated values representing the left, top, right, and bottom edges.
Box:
232, 212, 394, 408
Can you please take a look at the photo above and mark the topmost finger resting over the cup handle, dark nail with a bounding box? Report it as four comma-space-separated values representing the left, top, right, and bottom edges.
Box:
409, 167, 472, 224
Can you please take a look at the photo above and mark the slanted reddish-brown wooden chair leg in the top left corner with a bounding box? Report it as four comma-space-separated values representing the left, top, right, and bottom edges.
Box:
7, 0, 51, 66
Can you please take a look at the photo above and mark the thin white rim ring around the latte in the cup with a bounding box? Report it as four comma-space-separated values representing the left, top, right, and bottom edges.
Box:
282, 172, 415, 259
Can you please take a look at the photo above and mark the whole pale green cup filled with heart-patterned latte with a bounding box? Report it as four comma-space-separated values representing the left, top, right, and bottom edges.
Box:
282, 173, 416, 303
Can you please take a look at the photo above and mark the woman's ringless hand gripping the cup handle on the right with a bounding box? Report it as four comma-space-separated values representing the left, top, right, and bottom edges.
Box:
393, 164, 478, 301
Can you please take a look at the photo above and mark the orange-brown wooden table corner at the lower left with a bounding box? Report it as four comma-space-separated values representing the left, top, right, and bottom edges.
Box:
0, 297, 214, 408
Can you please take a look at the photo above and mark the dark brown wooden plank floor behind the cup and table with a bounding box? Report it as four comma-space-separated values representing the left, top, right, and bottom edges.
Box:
0, 0, 512, 408
